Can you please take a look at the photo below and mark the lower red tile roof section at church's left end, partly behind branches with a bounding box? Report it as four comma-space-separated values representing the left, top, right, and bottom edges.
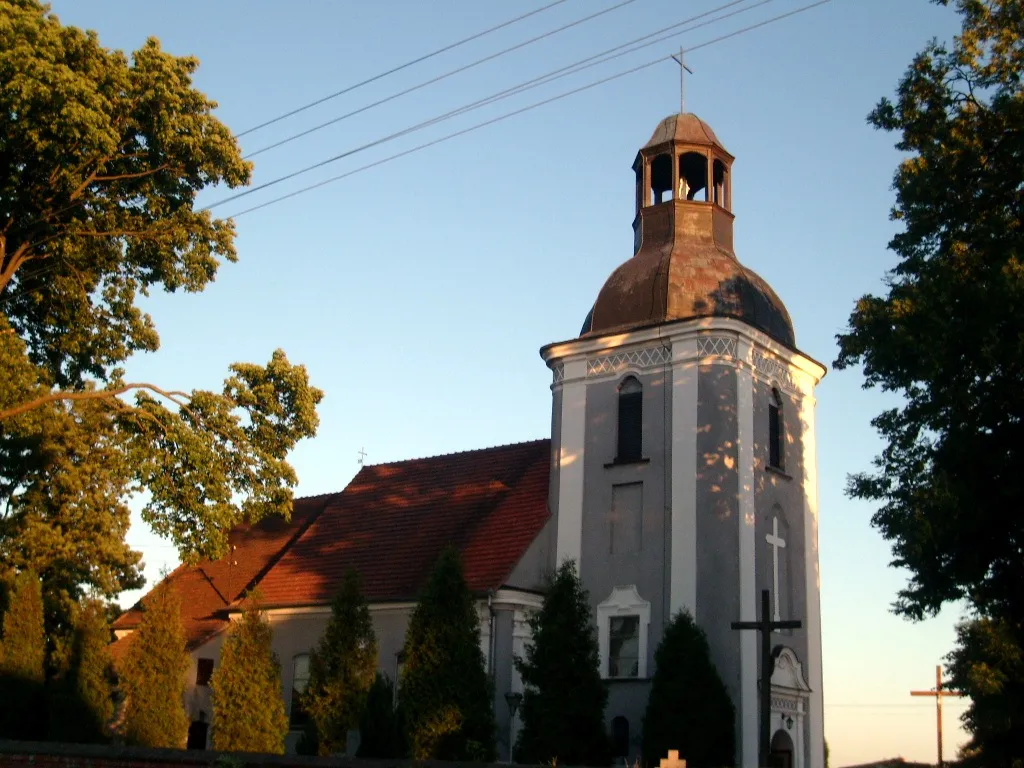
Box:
111, 494, 337, 657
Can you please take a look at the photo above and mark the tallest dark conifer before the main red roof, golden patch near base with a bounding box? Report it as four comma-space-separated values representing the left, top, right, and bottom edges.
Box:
398, 547, 495, 762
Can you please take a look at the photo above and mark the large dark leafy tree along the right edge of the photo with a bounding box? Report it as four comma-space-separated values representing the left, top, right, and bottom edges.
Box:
836, 0, 1024, 764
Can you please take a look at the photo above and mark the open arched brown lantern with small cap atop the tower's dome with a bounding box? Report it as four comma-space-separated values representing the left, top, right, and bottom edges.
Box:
633, 113, 734, 254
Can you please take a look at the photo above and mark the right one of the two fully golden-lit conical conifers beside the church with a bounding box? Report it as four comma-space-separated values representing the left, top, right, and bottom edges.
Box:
210, 595, 288, 755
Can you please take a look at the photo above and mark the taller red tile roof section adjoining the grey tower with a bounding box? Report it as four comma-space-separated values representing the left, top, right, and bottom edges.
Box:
253, 439, 551, 606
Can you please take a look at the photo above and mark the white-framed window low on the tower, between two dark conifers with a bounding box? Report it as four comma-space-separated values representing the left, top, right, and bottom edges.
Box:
597, 585, 650, 679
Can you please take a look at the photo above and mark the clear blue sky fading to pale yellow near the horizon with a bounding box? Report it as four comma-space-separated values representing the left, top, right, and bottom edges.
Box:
41, 0, 966, 766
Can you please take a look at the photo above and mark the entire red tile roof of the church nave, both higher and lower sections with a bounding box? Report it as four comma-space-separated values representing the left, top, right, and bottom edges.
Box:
112, 439, 551, 658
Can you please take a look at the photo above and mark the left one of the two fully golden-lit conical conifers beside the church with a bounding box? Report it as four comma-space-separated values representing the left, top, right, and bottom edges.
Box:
118, 581, 188, 749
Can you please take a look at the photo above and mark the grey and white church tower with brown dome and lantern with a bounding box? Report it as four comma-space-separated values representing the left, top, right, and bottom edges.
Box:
541, 114, 825, 768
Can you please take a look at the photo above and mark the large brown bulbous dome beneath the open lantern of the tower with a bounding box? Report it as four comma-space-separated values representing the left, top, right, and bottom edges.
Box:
581, 243, 796, 347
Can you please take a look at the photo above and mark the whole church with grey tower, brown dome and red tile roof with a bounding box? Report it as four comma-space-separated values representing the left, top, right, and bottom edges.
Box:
113, 114, 825, 768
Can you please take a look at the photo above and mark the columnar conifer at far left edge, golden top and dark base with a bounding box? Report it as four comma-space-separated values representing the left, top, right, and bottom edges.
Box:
0, 570, 46, 740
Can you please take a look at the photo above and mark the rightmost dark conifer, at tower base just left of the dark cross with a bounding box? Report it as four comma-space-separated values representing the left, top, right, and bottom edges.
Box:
643, 611, 735, 768
